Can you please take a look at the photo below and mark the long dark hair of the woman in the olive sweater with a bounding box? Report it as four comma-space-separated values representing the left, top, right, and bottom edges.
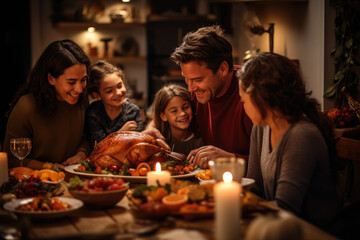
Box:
7, 39, 90, 116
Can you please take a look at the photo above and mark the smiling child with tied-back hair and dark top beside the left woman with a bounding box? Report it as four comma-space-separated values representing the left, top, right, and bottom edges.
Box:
86, 61, 143, 147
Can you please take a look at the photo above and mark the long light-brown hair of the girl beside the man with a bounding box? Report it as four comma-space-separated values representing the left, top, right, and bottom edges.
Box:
153, 84, 198, 141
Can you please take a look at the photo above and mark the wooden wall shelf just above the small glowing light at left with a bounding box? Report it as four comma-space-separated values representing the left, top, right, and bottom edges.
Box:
54, 22, 145, 30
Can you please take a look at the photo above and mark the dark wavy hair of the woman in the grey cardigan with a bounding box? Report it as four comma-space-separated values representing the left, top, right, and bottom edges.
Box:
238, 53, 336, 170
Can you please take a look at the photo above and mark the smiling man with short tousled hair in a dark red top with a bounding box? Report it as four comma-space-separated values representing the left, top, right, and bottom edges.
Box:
171, 26, 252, 168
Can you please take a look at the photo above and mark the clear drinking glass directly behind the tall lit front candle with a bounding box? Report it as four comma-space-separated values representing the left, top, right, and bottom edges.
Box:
209, 157, 245, 183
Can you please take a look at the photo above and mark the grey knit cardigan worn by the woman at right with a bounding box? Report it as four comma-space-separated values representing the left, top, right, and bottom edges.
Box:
247, 121, 338, 227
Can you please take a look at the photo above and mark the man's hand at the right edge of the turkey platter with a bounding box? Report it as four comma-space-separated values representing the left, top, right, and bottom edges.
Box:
186, 145, 235, 169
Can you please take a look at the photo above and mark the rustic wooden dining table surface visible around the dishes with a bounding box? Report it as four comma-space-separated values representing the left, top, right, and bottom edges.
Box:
0, 174, 337, 240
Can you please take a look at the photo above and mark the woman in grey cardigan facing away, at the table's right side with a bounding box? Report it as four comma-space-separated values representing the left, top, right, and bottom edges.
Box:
238, 53, 338, 227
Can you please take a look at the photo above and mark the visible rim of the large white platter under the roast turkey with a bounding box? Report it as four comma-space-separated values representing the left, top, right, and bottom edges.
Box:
65, 164, 204, 183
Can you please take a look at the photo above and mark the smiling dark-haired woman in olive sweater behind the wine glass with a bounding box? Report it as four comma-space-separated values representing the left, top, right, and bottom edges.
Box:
4, 40, 90, 169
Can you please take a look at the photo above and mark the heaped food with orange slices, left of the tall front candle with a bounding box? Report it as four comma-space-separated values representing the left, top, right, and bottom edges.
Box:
127, 179, 214, 220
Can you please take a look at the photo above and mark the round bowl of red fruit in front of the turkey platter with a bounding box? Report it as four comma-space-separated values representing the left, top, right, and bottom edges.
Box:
67, 176, 129, 209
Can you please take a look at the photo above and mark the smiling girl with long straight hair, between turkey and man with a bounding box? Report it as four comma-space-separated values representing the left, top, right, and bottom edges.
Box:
153, 84, 203, 155
